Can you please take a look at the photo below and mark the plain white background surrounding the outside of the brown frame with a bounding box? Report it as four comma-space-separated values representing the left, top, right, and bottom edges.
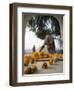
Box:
0, 0, 74, 90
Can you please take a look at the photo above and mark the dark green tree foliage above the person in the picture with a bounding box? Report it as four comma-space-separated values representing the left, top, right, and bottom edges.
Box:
29, 15, 60, 39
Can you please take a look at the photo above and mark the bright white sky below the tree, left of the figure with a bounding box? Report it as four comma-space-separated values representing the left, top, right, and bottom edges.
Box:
25, 27, 44, 49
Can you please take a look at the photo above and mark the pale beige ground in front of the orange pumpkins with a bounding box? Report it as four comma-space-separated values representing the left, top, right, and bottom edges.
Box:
24, 61, 63, 74
